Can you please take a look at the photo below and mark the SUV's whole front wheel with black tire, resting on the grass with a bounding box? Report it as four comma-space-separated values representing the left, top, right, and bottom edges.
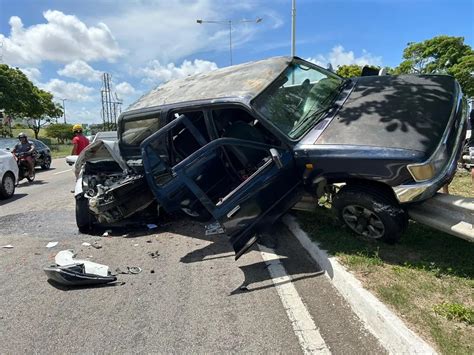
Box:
333, 185, 408, 244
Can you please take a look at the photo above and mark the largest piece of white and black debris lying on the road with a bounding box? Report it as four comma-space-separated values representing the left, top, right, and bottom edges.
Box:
43, 250, 117, 286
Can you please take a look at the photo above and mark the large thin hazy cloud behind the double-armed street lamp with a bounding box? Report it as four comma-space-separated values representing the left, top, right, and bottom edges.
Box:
101, 0, 268, 64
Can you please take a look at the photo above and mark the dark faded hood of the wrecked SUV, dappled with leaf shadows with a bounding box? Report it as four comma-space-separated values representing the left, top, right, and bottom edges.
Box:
315, 75, 456, 155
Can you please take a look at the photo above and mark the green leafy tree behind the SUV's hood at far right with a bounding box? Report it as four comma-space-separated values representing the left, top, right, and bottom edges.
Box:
396, 36, 474, 96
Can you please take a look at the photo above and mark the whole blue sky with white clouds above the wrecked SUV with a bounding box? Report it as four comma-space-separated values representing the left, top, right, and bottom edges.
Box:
0, 0, 474, 124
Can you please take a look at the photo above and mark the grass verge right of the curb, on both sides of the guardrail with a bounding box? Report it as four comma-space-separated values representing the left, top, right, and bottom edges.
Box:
297, 172, 474, 354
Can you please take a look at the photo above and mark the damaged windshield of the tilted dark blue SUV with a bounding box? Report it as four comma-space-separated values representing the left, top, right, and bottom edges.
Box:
253, 61, 344, 139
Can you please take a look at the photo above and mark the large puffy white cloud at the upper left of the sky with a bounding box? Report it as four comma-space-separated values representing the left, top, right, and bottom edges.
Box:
0, 10, 122, 65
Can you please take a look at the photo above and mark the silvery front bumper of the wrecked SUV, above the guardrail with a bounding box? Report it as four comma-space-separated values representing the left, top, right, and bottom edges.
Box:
392, 107, 466, 203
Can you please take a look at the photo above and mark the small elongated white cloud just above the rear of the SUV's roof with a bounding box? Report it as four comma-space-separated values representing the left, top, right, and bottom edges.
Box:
138, 59, 217, 84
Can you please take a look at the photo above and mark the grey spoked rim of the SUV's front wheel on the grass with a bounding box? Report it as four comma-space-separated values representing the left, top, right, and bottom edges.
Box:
342, 205, 385, 239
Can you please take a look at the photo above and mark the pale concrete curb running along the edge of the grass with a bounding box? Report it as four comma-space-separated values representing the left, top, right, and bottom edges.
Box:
283, 215, 436, 354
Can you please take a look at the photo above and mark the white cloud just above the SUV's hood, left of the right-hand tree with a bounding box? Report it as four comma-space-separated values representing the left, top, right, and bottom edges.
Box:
307, 45, 382, 69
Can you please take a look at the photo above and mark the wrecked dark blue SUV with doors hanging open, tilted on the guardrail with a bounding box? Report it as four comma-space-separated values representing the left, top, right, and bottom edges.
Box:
75, 57, 467, 258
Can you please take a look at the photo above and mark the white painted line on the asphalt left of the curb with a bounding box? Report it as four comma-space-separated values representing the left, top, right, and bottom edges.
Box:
258, 245, 331, 354
